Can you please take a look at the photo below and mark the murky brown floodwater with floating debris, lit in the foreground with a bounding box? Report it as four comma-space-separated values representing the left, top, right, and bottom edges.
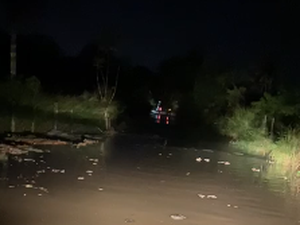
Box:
0, 135, 300, 225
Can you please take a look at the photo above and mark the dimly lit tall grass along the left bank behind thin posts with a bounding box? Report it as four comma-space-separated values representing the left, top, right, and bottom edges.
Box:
0, 78, 120, 131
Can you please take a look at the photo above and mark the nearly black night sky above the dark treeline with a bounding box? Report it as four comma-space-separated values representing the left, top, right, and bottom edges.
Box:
0, 0, 299, 71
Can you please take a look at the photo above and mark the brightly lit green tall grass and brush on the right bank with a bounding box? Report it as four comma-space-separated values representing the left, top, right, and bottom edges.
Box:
219, 108, 300, 173
